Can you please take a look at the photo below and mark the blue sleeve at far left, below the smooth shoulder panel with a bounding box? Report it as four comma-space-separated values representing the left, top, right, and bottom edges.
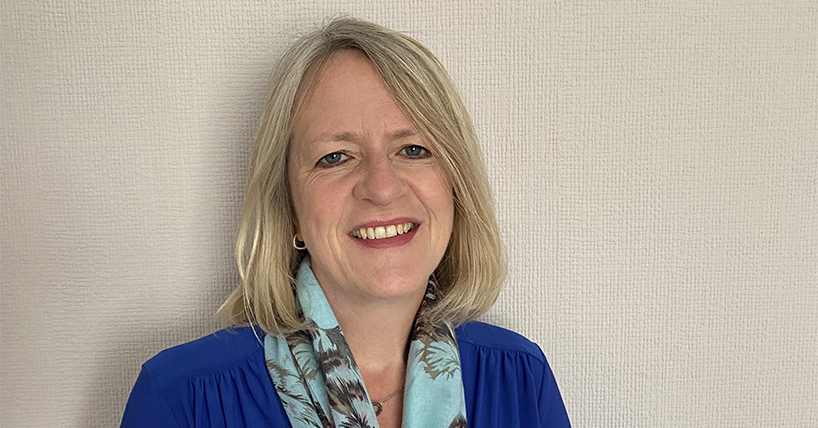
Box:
120, 366, 180, 428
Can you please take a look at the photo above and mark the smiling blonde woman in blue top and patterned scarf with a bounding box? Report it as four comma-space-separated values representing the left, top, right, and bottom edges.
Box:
122, 19, 569, 428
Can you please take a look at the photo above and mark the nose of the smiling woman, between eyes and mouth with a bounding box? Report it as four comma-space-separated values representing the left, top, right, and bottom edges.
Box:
353, 156, 406, 207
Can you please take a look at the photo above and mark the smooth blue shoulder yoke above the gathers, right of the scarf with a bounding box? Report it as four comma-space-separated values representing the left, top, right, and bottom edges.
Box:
455, 321, 545, 363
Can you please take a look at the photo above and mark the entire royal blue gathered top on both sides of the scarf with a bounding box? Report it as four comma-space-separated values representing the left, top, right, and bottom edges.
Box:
121, 322, 570, 428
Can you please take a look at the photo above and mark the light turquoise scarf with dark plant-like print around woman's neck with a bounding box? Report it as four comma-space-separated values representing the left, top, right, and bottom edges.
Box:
264, 258, 466, 428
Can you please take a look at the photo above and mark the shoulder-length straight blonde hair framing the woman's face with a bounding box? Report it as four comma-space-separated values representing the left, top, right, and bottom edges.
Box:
219, 18, 506, 332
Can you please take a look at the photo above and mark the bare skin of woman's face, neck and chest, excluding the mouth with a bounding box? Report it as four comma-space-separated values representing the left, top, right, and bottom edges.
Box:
288, 50, 454, 427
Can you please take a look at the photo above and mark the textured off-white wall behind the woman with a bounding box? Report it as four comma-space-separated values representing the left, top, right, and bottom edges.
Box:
0, 0, 818, 427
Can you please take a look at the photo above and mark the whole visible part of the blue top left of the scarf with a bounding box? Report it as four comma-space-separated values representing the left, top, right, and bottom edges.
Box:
121, 327, 286, 428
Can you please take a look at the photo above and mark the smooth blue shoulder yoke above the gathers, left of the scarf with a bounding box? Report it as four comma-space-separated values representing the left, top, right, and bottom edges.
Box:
143, 327, 264, 387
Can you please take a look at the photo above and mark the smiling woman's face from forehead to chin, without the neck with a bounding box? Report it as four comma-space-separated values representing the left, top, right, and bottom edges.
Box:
288, 50, 454, 303
